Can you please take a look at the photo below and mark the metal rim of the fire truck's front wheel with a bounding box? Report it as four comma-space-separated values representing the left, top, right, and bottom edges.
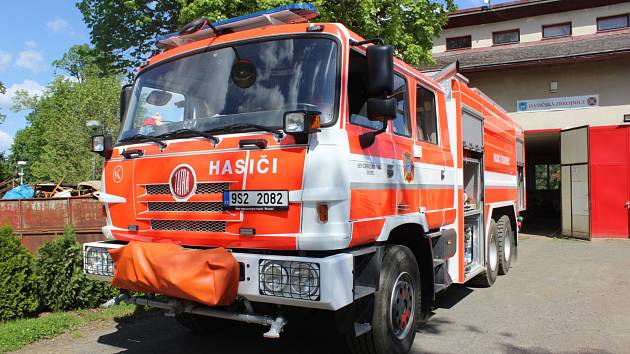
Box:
389, 272, 416, 339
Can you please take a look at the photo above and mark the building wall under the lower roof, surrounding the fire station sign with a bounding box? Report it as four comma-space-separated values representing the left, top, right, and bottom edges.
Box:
465, 57, 630, 130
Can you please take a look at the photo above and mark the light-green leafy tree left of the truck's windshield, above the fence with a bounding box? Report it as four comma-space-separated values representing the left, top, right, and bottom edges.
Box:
10, 76, 120, 183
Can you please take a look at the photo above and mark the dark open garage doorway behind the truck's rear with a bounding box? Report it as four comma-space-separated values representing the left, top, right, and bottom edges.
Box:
523, 130, 562, 236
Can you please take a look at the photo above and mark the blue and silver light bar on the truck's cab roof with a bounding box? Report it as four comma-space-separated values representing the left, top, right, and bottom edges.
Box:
156, 4, 318, 49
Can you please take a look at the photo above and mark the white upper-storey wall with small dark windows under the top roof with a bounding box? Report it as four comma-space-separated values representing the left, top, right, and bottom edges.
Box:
433, 1, 630, 54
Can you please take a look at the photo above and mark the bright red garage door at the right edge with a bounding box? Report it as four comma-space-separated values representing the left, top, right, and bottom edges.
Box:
589, 126, 630, 238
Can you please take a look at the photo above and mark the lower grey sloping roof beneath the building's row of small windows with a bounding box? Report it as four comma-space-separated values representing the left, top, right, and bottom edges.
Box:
430, 30, 630, 72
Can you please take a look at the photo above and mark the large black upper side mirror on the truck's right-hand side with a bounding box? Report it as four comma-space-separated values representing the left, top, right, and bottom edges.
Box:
366, 45, 394, 97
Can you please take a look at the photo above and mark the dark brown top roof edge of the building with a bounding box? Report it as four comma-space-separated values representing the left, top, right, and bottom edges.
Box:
444, 0, 628, 29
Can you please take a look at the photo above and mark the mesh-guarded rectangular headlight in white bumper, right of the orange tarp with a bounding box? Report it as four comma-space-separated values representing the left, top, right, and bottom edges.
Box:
258, 259, 320, 301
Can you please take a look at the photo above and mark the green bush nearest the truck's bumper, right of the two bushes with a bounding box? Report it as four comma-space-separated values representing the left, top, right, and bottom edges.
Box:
36, 226, 118, 311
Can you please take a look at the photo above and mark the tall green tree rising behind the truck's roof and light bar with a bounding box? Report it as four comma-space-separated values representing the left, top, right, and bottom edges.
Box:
77, 0, 455, 71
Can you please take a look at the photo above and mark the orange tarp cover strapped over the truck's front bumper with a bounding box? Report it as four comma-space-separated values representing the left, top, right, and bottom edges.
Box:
109, 242, 240, 306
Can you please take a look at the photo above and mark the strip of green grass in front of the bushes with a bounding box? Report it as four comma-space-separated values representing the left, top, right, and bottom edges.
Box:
0, 304, 136, 353
